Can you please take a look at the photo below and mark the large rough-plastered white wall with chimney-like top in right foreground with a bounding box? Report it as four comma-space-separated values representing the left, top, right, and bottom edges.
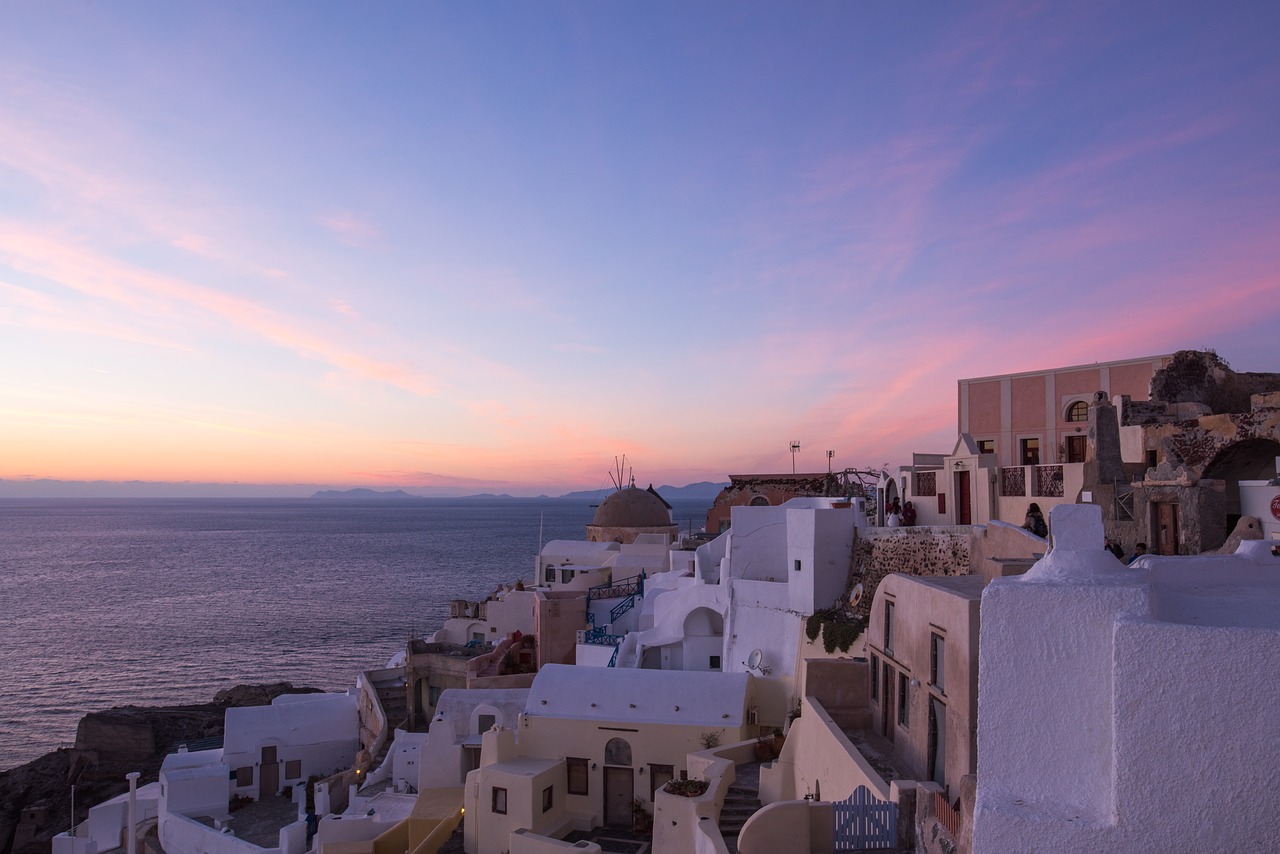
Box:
973, 506, 1280, 854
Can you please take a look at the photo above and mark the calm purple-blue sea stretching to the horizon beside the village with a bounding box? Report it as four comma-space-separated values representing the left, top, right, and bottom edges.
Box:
0, 498, 710, 771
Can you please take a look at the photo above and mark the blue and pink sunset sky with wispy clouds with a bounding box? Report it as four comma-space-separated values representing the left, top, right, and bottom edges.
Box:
0, 0, 1280, 494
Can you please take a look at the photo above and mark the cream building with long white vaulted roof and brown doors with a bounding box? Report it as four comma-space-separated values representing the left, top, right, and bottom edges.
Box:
465, 665, 754, 854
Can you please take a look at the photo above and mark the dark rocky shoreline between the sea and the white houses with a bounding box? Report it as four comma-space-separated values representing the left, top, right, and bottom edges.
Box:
0, 682, 320, 854
